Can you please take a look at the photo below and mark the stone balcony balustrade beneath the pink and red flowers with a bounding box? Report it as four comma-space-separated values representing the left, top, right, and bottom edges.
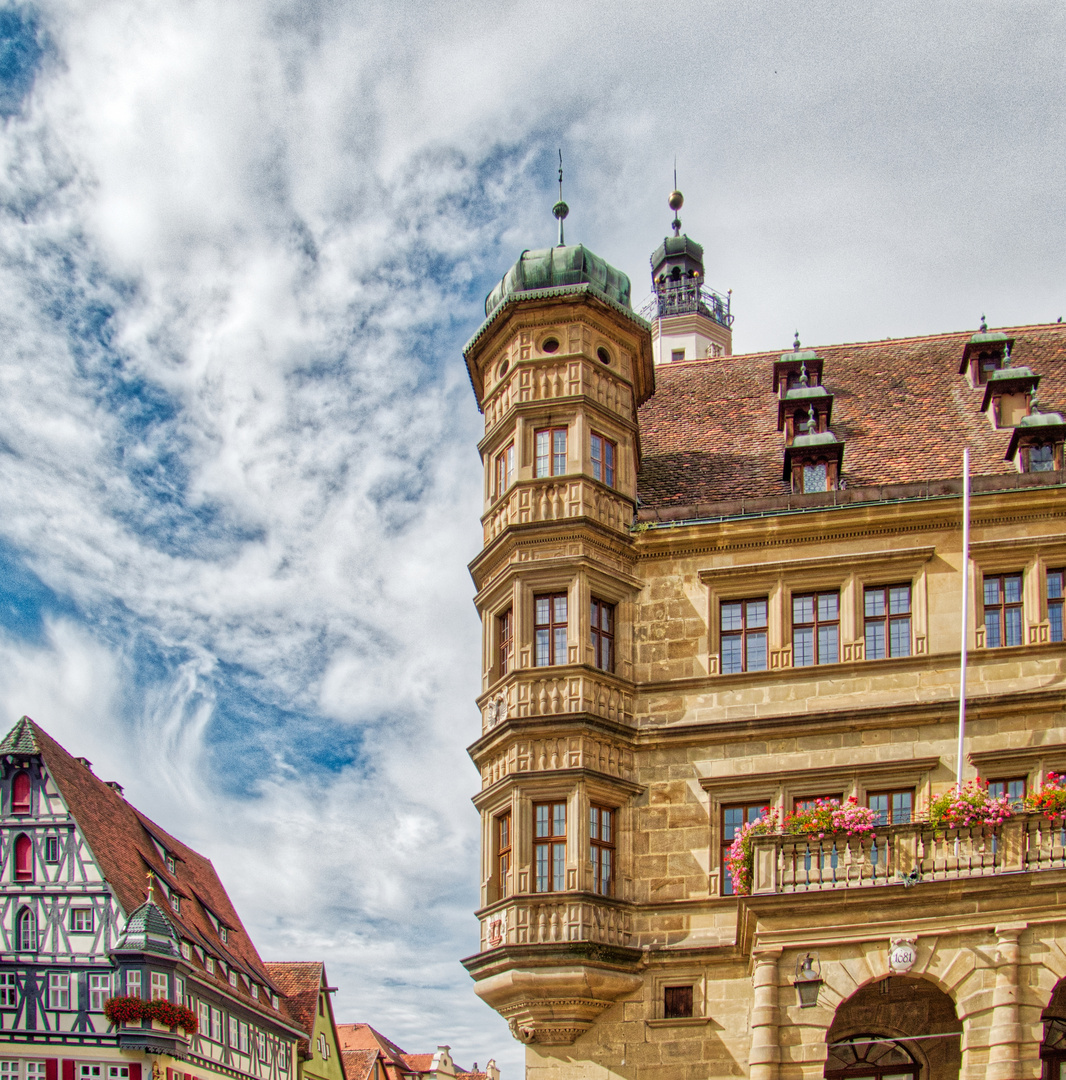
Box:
752, 814, 1066, 895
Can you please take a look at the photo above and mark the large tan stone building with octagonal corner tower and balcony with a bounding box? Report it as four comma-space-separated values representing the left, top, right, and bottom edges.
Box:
464, 199, 1066, 1080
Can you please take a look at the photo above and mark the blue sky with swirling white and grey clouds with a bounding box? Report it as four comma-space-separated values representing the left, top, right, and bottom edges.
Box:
0, 0, 1066, 1080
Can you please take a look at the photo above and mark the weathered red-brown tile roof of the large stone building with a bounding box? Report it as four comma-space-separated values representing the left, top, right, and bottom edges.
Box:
638, 323, 1066, 510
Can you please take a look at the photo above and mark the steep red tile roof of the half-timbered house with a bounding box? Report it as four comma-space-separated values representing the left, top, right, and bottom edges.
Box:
10, 716, 292, 1024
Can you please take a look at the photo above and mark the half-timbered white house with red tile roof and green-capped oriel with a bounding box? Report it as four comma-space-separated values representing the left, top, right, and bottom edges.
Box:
0, 717, 303, 1080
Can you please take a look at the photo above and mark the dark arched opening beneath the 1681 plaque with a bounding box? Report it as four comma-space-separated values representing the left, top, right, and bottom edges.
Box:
824, 975, 967, 1080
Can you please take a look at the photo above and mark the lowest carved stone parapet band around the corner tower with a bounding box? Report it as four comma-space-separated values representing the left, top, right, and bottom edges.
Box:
478, 892, 633, 953
